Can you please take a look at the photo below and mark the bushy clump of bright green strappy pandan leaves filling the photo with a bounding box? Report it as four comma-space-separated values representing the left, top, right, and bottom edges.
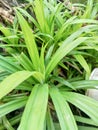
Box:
0, 0, 98, 130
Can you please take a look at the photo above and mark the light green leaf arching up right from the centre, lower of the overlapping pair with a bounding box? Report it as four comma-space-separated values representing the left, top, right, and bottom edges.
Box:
46, 37, 87, 77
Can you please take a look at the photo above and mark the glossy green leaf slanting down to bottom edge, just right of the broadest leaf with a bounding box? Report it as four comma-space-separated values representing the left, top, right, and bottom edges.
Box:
50, 88, 78, 130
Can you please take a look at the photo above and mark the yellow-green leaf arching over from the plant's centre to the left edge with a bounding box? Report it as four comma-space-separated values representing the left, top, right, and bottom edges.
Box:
0, 71, 43, 99
